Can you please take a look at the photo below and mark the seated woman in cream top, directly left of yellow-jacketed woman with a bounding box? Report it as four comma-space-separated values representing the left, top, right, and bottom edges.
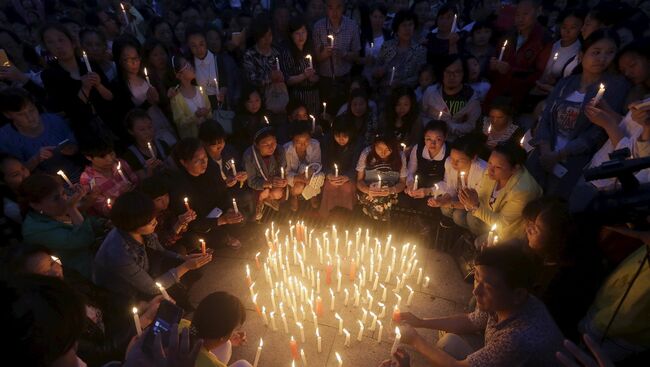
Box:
427, 134, 487, 228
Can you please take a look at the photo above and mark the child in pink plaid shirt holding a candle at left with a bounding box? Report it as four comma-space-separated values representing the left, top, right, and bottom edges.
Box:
79, 138, 139, 217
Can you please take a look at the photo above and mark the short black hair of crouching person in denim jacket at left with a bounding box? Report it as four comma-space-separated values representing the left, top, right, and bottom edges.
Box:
110, 190, 155, 232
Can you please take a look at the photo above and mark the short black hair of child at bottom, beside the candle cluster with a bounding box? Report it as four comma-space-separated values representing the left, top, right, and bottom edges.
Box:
192, 292, 246, 339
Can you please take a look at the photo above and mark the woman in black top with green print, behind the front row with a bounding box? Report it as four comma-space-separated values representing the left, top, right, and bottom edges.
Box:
422, 55, 481, 141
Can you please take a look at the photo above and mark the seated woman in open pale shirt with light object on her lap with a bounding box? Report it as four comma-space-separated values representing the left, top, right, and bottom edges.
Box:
284, 122, 325, 212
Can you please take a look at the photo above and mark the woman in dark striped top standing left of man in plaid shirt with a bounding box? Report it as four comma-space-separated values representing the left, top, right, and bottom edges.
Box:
280, 17, 320, 116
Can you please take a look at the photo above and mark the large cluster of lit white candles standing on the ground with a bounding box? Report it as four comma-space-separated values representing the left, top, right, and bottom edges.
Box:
245, 222, 430, 366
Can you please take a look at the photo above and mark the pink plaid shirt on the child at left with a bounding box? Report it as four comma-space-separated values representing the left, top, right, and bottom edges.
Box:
79, 159, 138, 217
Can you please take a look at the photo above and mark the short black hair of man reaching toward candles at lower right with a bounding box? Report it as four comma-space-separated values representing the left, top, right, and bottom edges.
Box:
474, 241, 535, 290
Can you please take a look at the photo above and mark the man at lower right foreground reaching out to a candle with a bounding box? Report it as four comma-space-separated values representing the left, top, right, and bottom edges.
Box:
400, 245, 564, 366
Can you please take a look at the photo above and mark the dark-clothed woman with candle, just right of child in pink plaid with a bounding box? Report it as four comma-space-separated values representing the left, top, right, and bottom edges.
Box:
119, 108, 171, 180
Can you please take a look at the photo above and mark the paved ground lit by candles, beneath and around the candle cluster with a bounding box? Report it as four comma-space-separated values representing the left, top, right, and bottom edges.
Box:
190, 208, 471, 367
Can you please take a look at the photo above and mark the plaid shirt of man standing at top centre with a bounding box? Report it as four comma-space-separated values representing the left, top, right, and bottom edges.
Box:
314, 16, 361, 78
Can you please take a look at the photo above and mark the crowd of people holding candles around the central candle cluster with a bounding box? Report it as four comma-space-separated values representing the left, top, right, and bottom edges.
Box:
0, 0, 650, 367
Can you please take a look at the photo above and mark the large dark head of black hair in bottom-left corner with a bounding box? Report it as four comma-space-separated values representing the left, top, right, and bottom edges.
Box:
0, 274, 86, 367
